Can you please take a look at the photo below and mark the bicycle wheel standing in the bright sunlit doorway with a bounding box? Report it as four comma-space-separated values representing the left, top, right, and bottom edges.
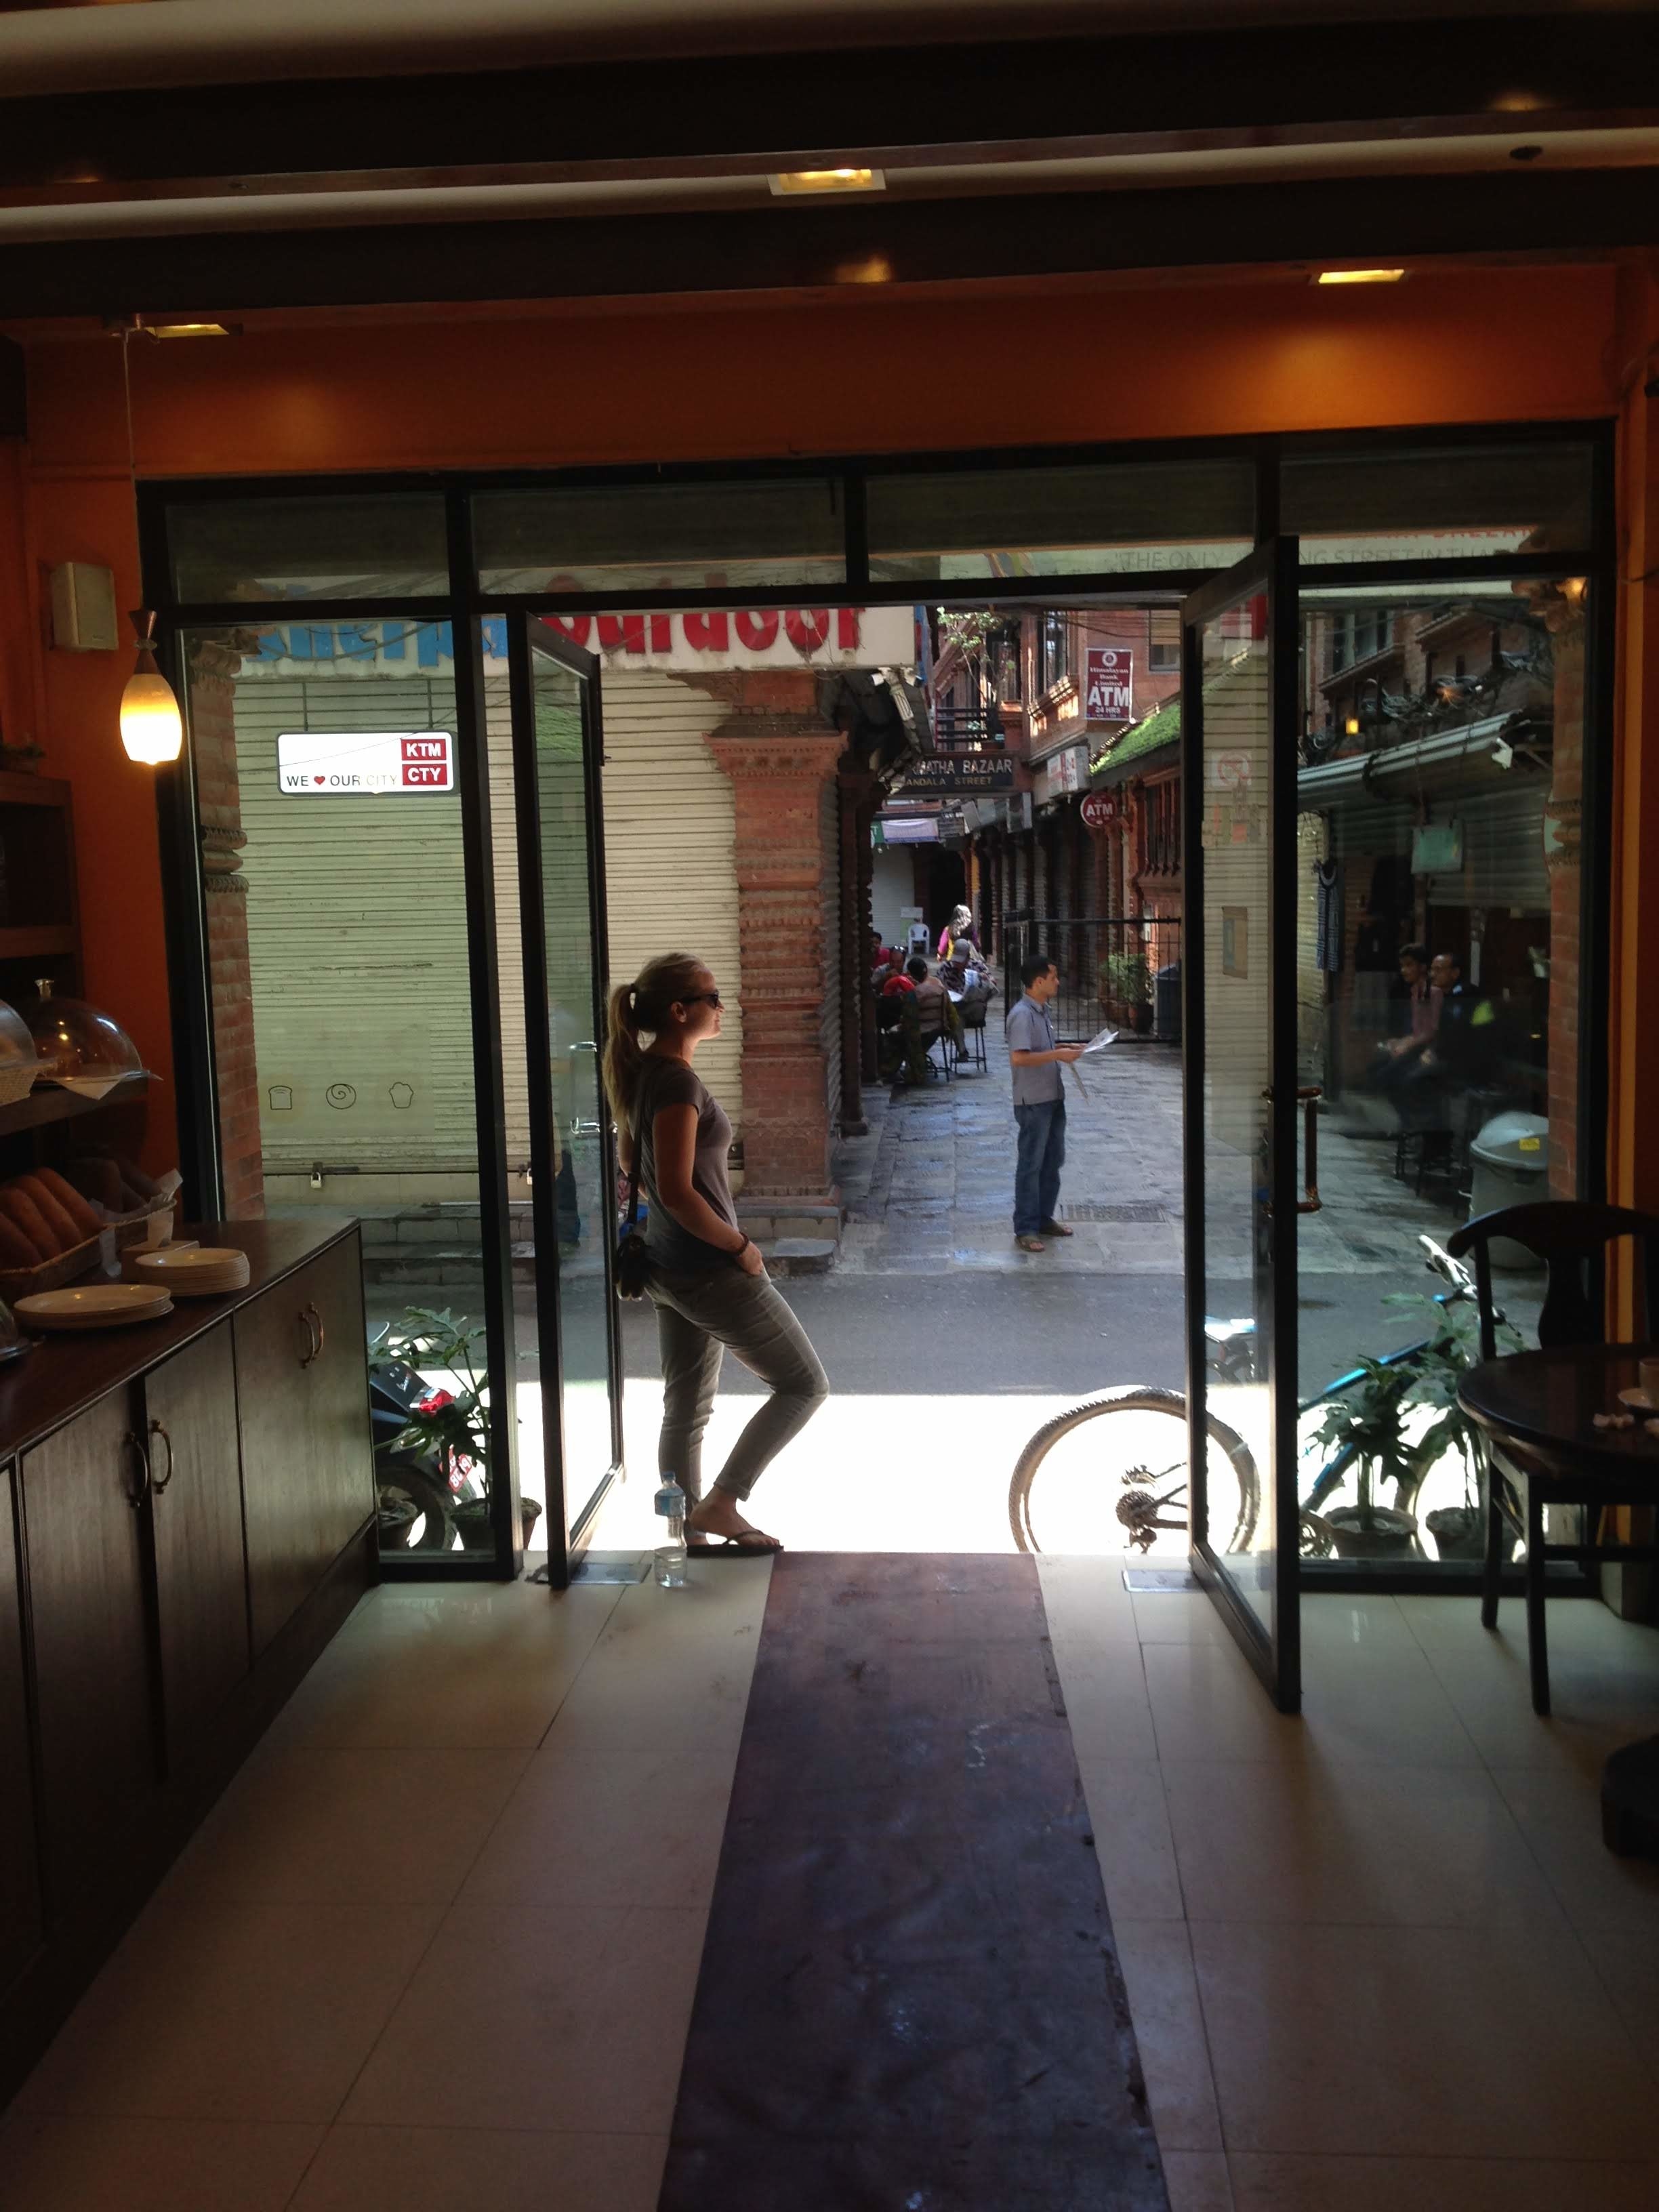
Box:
1008, 1385, 1261, 1553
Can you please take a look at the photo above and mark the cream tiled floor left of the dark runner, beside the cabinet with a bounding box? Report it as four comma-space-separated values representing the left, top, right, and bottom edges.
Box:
0, 1561, 768, 2212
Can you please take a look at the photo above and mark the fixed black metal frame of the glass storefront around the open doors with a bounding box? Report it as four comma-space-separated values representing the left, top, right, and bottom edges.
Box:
137, 418, 1617, 1593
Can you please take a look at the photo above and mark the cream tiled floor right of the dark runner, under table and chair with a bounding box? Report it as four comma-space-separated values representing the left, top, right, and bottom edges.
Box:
1042, 1559, 1659, 2212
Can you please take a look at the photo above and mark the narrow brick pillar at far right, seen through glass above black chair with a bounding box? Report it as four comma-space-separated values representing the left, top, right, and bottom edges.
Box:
1542, 597, 1584, 1199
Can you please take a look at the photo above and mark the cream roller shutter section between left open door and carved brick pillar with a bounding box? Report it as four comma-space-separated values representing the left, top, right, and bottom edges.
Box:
602, 670, 743, 1139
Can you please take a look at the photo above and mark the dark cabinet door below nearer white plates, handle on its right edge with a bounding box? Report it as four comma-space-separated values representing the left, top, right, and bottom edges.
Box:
22, 1389, 159, 1916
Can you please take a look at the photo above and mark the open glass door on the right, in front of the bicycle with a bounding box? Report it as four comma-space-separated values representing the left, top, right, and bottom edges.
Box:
1181, 537, 1314, 1712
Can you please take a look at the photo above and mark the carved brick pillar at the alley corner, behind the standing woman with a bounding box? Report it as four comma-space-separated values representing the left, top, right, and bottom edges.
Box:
708, 712, 845, 1199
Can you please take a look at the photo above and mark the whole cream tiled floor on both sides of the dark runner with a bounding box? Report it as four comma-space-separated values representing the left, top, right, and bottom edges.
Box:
0, 1559, 1659, 2212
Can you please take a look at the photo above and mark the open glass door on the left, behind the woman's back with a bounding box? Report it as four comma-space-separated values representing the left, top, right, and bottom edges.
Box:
504, 615, 621, 1589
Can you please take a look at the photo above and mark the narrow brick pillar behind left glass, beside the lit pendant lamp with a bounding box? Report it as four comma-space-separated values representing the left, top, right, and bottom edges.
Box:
190, 633, 266, 1221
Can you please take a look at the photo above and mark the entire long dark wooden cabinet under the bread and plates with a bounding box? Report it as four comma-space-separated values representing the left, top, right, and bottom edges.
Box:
0, 1221, 376, 2097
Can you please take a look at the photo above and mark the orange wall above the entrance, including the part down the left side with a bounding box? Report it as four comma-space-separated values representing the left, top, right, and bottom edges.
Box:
0, 267, 1659, 1201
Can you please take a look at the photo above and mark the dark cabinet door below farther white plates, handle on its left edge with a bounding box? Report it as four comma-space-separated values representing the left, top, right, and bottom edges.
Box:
144, 1323, 248, 1771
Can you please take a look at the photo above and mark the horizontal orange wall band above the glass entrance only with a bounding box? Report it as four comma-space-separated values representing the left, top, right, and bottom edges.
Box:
16, 265, 1615, 476
